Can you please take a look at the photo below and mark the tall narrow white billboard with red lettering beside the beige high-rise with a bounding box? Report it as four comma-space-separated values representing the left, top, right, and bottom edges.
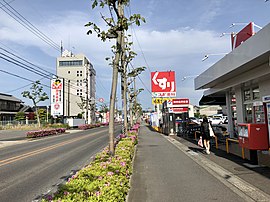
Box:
51, 78, 64, 116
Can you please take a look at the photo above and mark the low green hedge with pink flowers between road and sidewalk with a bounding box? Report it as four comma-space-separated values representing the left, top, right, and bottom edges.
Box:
43, 131, 137, 202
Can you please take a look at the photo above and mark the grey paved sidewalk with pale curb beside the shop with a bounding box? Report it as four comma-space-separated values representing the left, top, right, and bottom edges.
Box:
128, 125, 270, 202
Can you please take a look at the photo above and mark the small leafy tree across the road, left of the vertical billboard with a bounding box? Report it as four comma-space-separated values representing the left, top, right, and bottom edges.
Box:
22, 81, 49, 127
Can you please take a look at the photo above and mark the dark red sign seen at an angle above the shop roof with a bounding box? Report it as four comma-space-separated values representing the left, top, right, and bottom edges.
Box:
231, 22, 254, 49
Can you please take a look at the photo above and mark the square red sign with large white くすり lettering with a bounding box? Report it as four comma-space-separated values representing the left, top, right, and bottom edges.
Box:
151, 71, 176, 93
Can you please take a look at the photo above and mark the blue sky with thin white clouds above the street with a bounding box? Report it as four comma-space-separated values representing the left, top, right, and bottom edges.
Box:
0, 0, 270, 109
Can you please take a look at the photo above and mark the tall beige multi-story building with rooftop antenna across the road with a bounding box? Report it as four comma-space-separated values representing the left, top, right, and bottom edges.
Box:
56, 51, 96, 123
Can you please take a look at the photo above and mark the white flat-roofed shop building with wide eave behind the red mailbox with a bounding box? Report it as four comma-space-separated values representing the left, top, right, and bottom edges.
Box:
195, 24, 270, 165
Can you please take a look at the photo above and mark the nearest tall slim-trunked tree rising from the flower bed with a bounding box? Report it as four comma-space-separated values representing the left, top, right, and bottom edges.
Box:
85, 0, 145, 155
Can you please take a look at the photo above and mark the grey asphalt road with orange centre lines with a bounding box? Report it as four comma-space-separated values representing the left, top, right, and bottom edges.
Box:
0, 126, 121, 202
